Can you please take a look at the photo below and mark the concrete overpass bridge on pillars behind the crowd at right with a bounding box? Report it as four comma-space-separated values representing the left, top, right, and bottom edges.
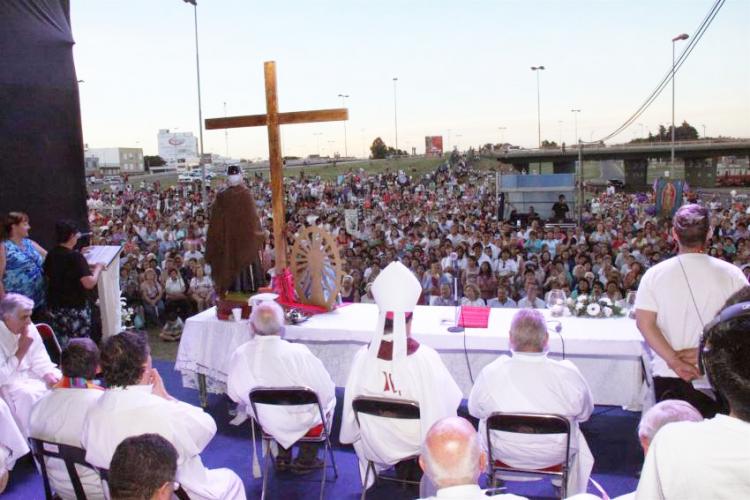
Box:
487, 139, 750, 187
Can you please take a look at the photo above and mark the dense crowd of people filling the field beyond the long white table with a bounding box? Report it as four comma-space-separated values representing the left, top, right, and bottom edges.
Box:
0, 160, 728, 340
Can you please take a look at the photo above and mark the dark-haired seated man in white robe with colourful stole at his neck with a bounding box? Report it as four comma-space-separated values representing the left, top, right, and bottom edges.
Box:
29, 337, 105, 500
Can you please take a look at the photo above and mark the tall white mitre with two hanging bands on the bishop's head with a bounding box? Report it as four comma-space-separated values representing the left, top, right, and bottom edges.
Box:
368, 262, 422, 365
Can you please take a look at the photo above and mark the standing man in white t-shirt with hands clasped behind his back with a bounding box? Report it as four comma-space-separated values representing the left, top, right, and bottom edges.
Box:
635, 204, 747, 417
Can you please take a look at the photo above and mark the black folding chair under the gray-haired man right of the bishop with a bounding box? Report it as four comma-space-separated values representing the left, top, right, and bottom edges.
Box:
486, 412, 570, 498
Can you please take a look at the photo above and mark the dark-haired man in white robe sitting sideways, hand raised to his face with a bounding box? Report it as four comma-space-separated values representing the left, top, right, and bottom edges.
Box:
81, 332, 245, 500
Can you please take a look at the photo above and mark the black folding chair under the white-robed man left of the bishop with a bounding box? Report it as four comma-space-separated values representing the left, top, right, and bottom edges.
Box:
250, 387, 339, 500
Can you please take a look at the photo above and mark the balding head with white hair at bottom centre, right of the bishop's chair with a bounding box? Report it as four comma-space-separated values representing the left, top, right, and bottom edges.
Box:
419, 417, 486, 488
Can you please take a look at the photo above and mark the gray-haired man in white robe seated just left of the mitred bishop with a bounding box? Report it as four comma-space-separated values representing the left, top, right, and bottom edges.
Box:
227, 302, 336, 471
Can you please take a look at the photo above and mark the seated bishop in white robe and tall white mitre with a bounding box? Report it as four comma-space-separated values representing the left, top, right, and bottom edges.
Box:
340, 262, 462, 488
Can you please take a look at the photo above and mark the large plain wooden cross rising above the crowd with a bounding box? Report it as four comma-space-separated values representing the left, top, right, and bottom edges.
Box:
206, 61, 349, 273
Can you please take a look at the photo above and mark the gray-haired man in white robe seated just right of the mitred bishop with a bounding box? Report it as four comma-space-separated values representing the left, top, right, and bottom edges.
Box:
469, 309, 594, 495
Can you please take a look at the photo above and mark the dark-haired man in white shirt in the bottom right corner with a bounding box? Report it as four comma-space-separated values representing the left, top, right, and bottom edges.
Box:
636, 296, 750, 500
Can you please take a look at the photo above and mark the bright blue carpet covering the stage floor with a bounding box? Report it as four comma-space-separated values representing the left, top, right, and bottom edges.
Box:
2, 360, 643, 500
